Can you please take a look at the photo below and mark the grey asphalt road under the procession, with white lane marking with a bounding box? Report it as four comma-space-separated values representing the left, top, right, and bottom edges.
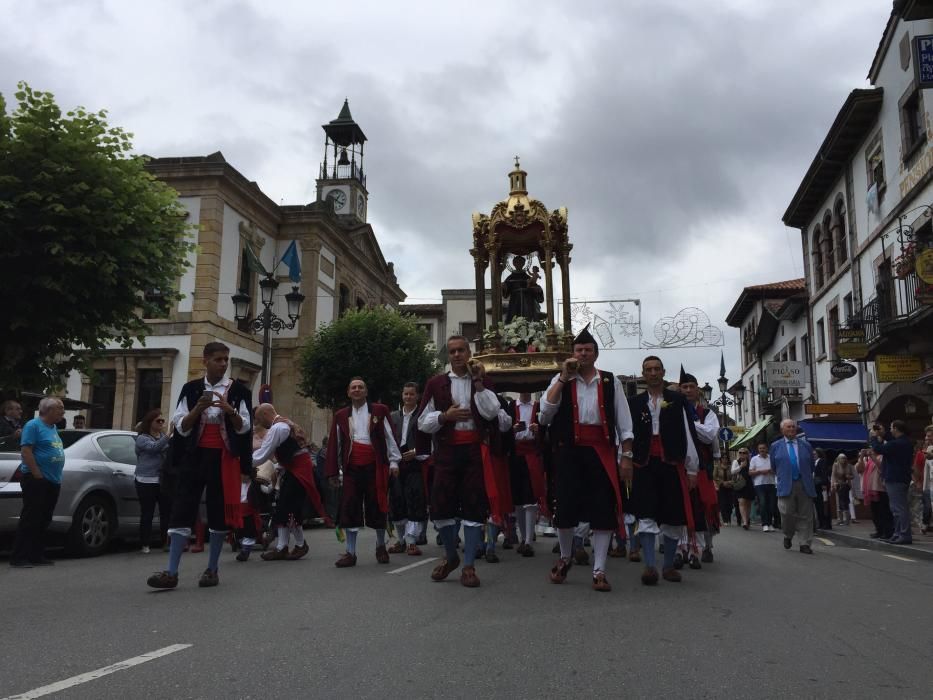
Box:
0, 528, 933, 700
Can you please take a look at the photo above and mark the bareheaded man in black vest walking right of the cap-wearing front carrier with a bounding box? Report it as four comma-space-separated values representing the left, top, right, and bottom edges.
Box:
623, 355, 699, 586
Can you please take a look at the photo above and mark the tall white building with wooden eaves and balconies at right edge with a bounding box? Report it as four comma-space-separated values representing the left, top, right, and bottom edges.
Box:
783, 0, 933, 430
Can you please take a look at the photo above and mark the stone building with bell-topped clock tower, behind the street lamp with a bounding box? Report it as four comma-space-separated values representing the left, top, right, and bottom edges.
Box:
67, 102, 405, 442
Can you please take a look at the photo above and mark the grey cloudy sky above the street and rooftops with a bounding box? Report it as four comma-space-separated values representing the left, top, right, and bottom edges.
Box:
0, 0, 891, 394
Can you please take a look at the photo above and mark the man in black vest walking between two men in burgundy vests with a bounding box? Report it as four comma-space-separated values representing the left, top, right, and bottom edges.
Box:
389, 382, 429, 556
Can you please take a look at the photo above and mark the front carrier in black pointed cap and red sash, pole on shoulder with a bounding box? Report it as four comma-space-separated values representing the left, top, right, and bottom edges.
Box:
541, 326, 632, 592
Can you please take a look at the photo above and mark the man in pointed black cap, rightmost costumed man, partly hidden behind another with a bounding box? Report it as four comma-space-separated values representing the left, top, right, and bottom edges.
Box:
680, 367, 719, 569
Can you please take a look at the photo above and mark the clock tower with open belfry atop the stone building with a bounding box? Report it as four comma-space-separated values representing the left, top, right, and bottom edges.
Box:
317, 100, 369, 223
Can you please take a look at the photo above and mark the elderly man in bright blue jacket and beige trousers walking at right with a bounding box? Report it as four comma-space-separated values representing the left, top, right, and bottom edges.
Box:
770, 418, 816, 554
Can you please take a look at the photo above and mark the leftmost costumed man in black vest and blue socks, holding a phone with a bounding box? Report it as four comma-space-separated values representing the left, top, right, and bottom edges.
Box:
147, 342, 253, 588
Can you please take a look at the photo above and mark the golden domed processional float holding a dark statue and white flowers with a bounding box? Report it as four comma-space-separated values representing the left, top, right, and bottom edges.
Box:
470, 157, 573, 391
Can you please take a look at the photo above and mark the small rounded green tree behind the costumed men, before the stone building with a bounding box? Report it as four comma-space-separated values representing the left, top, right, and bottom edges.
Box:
298, 308, 439, 409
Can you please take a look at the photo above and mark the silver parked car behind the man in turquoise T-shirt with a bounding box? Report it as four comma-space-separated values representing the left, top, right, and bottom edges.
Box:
0, 430, 158, 557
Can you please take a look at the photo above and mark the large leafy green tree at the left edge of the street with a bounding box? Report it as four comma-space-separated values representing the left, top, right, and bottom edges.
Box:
0, 83, 193, 389
